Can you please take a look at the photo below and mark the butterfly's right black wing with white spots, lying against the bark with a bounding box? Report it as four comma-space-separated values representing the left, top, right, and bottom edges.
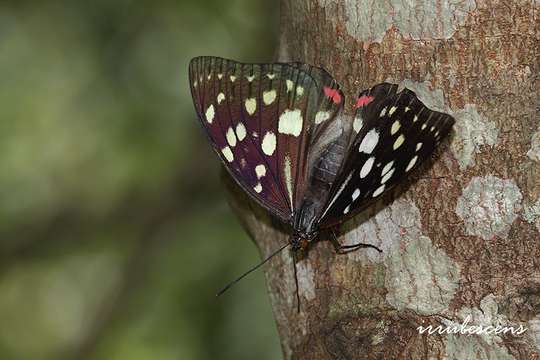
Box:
320, 83, 454, 227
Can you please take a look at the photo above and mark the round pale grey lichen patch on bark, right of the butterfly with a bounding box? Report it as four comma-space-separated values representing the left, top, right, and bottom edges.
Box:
456, 175, 522, 240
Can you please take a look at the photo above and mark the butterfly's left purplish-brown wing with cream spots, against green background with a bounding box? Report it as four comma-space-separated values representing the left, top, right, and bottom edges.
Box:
189, 57, 344, 222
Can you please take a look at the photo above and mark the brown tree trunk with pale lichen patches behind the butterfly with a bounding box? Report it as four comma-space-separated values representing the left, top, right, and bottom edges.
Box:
225, 0, 540, 359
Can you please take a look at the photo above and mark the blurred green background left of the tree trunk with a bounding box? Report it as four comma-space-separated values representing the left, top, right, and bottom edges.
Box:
0, 0, 281, 360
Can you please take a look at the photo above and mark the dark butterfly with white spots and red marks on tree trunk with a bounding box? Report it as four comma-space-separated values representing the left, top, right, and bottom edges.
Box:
189, 56, 454, 306
